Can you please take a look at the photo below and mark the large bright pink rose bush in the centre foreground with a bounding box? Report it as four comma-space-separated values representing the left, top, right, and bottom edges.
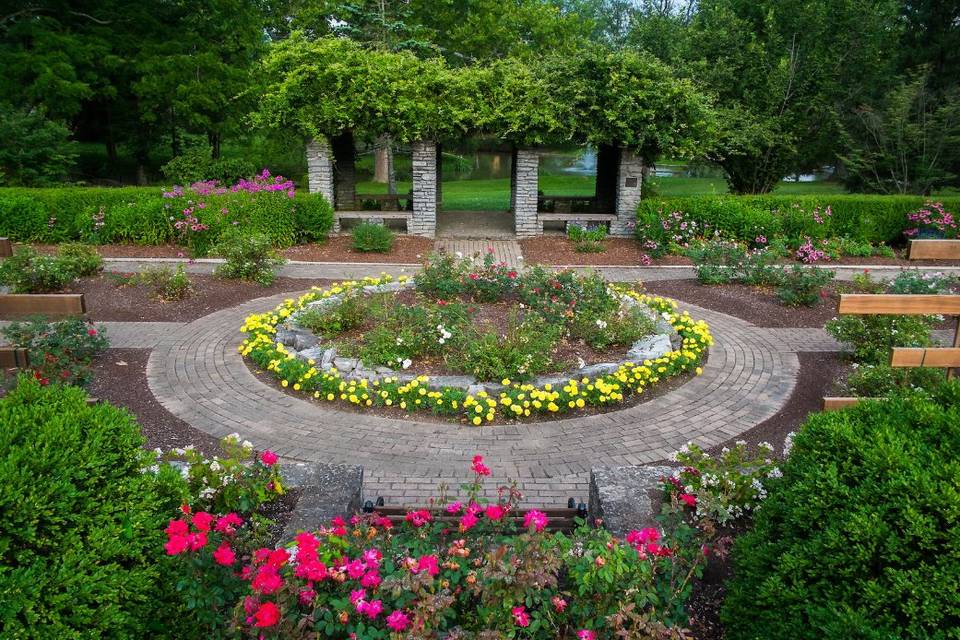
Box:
168, 456, 707, 640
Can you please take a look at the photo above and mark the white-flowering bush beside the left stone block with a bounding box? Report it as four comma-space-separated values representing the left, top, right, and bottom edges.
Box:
155, 433, 284, 516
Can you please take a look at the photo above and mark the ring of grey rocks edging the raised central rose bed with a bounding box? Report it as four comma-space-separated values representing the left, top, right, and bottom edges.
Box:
276, 280, 682, 395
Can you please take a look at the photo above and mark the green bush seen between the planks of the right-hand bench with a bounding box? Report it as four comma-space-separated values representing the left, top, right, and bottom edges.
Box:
826, 315, 935, 365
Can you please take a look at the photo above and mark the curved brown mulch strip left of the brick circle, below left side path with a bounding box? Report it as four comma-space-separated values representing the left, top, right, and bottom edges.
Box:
89, 349, 221, 457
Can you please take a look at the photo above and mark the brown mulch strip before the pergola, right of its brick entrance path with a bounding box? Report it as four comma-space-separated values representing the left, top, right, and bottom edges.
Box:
520, 236, 693, 267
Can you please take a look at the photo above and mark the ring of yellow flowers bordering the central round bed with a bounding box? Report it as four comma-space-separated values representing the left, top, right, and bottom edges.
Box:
238, 274, 713, 426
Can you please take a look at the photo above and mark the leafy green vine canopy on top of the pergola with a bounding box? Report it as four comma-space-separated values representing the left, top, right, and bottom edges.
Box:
256, 34, 713, 158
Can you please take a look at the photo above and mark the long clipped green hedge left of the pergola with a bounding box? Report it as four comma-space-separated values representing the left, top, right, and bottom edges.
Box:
0, 187, 333, 246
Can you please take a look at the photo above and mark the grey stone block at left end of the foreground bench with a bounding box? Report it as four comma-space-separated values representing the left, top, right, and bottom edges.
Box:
283, 463, 363, 541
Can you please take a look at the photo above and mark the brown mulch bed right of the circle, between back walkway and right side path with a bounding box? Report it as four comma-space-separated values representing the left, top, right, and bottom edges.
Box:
644, 279, 844, 328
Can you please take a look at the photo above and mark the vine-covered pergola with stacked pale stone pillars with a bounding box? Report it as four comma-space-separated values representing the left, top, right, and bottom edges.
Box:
256, 34, 711, 237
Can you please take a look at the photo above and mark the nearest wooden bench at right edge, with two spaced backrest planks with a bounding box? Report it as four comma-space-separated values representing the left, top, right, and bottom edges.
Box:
823, 294, 960, 411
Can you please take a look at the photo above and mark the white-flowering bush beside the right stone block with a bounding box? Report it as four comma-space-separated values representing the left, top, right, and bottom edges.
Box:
664, 440, 782, 524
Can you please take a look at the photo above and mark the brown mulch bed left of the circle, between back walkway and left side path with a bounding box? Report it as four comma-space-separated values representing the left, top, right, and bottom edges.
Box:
65, 273, 331, 322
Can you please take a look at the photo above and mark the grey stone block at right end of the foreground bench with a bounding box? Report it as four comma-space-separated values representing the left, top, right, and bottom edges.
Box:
589, 466, 672, 537
